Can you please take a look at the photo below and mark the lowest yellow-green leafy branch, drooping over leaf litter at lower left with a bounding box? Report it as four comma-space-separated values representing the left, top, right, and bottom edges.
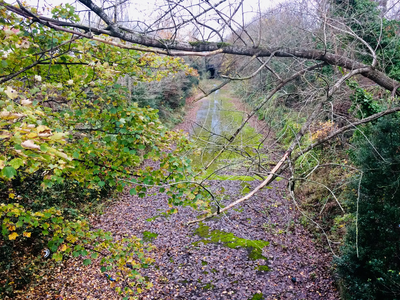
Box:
0, 203, 153, 295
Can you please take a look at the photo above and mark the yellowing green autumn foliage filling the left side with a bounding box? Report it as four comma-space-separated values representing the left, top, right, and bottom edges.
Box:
0, 4, 203, 297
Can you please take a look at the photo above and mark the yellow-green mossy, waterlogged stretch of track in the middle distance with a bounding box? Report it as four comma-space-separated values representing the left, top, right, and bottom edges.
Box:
191, 84, 267, 181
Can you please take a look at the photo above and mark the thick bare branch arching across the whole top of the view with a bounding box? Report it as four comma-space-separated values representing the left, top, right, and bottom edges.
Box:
0, 0, 400, 95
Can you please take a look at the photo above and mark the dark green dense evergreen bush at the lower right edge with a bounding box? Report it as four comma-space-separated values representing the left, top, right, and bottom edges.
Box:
336, 115, 400, 299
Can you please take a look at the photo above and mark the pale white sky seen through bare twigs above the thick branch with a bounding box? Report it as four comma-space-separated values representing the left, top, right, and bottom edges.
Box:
18, 0, 284, 41
